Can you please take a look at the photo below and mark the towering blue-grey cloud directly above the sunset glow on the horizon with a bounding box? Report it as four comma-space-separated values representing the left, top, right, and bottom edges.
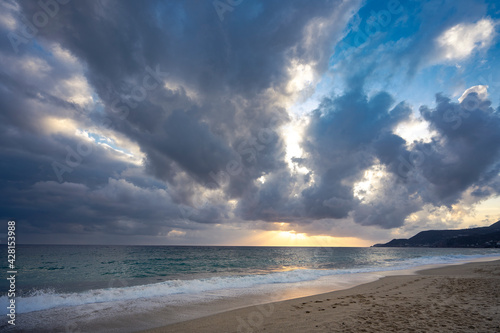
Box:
239, 83, 411, 227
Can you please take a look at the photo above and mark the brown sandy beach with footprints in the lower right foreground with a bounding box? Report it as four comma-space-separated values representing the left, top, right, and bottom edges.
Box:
143, 260, 500, 333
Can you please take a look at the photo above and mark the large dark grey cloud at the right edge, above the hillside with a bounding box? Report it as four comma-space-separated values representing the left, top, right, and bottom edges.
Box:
353, 89, 500, 228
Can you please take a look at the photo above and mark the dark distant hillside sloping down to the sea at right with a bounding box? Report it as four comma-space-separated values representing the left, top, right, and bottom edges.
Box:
373, 221, 500, 247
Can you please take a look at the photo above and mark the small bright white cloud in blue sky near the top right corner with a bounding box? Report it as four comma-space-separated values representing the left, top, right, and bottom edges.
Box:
435, 19, 496, 62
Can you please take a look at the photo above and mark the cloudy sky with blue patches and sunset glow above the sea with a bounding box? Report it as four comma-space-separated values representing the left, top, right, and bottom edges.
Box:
0, 0, 500, 246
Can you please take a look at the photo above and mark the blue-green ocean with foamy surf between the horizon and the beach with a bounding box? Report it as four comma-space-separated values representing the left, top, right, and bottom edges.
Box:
0, 245, 500, 330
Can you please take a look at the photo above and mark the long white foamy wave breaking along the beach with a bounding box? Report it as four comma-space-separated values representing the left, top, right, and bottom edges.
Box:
0, 255, 493, 313
